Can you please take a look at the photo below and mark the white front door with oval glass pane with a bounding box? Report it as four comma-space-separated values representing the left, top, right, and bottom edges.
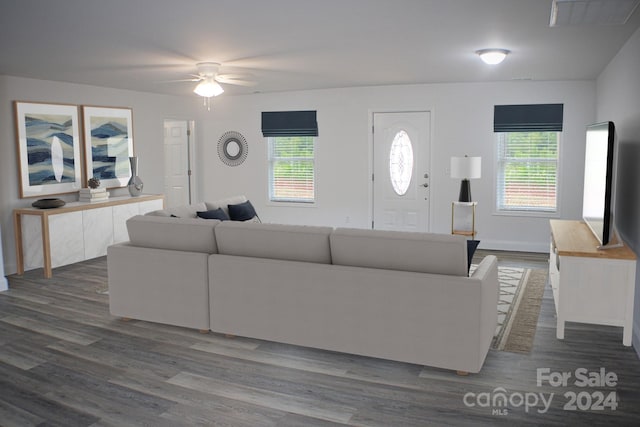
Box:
373, 111, 431, 232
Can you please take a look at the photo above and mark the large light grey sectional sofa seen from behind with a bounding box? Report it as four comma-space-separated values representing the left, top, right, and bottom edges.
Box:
108, 199, 498, 372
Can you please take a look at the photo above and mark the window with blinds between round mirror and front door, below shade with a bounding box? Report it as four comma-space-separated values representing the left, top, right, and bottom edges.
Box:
267, 136, 316, 203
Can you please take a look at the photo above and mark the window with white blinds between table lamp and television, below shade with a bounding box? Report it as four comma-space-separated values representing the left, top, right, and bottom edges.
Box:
496, 132, 560, 213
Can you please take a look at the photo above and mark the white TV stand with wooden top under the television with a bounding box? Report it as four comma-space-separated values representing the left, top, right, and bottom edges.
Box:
549, 220, 636, 346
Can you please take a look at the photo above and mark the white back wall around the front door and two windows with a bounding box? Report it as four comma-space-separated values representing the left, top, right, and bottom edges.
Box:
200, 81, 596, 252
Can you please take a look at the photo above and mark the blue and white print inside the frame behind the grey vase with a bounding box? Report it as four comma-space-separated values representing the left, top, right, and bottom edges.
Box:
91, 116, 130, 179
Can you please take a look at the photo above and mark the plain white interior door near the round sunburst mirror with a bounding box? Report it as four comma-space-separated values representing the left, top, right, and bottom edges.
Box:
164, 120, 191, 207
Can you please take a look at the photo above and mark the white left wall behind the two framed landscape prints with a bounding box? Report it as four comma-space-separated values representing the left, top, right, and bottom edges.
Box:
0, 76, 206, 274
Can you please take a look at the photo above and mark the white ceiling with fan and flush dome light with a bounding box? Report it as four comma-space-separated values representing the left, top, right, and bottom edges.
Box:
0, 0, 640, 96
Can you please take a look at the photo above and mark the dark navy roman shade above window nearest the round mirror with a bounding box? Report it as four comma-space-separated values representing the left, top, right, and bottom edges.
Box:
262, 111, 318, 137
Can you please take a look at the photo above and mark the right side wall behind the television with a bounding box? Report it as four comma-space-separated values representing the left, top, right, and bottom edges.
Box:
597, 25, 640, 355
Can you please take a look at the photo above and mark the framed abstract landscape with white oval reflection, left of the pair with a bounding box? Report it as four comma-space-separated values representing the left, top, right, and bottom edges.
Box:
14, 101, 82, 198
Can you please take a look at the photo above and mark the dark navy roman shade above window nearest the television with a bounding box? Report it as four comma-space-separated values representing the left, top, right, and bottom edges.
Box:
493, 104, 564, 132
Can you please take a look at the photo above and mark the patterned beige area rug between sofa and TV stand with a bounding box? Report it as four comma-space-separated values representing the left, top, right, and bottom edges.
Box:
471, 265, 547, 353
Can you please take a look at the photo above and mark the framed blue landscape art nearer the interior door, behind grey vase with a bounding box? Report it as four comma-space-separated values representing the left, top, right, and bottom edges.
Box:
82, 106, 133, 188
